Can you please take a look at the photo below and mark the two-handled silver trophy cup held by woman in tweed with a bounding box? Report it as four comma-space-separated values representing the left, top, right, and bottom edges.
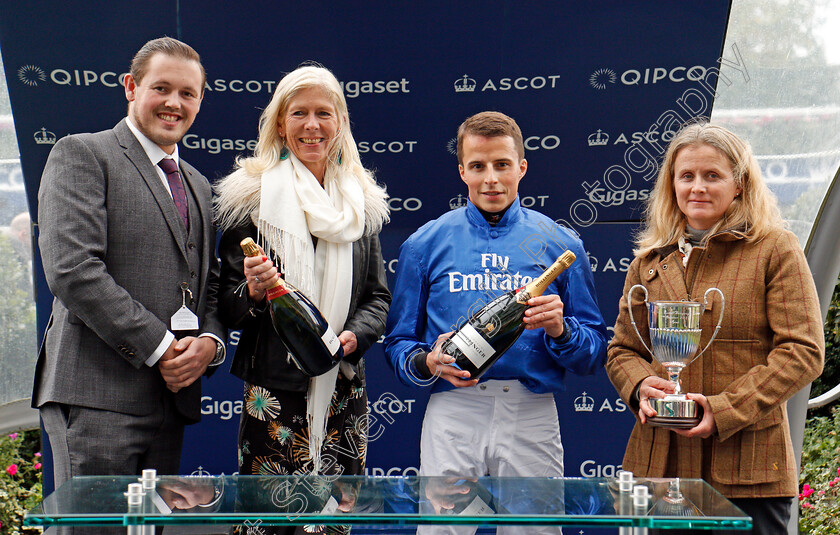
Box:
627, 284, 725, 429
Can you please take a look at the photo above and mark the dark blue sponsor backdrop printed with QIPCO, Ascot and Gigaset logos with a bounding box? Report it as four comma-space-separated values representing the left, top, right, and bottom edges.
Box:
0, 0, 736, 498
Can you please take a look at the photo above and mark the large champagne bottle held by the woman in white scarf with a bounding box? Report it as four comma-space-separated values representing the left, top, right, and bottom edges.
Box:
239, 238, 344, 377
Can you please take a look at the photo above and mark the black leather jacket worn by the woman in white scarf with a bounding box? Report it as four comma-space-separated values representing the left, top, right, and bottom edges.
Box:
219, 223, 391, 392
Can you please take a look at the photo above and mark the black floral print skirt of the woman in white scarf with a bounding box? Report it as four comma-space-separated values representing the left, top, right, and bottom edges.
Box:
233, 372, 368, 535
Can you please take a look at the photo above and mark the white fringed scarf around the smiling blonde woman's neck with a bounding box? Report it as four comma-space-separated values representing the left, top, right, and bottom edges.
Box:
254, 154, 365, 474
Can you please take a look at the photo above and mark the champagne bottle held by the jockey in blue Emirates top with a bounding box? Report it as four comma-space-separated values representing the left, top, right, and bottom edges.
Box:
441, 251, 575, 379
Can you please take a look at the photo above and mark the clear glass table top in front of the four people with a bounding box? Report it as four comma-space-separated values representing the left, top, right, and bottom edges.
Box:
24, 475, 752, 530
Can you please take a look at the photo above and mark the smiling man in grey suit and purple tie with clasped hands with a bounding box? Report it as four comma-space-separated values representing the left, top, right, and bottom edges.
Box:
32, 37, 226, 502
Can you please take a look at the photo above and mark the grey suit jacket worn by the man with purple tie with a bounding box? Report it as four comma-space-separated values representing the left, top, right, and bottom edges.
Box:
32, 119, 226, 421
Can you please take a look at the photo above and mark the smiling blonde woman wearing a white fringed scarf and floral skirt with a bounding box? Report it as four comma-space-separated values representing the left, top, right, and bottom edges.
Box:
216, 65, 391, 535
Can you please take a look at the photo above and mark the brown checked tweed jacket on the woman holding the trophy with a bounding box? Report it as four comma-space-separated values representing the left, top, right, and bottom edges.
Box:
606, 227, 825, 498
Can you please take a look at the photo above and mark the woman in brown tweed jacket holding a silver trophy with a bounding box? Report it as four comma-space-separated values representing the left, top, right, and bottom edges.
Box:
607, 123, 825, 533
